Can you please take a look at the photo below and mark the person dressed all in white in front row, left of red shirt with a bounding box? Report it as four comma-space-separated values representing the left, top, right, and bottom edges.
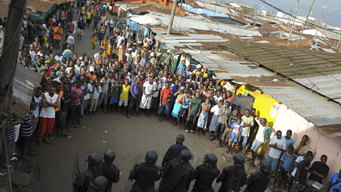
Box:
140, 78, 156, 117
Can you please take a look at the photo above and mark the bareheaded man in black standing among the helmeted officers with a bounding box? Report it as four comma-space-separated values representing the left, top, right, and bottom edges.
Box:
161, 134, 189, 167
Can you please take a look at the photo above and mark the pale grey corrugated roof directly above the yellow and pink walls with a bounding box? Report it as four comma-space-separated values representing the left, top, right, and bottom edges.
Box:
259, 86, 341, 128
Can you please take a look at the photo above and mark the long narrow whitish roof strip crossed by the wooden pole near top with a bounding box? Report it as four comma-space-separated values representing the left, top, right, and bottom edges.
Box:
151, 12, 261, 36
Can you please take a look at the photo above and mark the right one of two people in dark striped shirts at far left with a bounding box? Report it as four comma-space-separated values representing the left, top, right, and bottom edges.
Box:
20, 101, 38, 161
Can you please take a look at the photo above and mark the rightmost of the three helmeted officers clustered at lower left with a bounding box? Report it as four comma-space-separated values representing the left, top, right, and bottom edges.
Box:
102, 149, 120, 192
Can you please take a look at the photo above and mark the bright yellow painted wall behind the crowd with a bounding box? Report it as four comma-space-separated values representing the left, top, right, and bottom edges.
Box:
236, 85, 279, 155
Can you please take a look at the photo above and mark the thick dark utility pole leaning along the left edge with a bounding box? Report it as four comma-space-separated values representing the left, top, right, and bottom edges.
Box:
0, 0, 26, 192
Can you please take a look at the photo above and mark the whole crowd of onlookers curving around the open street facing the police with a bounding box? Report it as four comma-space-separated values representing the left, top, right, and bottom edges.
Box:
0, 1, 340, 191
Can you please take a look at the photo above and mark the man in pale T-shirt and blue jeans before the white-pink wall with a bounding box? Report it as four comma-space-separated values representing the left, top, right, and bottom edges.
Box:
266, 130, 286, 176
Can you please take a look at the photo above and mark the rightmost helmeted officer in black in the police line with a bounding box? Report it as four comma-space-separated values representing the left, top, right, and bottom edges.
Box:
244, 160, 271, 192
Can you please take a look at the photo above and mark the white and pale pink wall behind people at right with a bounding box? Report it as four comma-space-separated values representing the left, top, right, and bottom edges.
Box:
265, 104, 341, 188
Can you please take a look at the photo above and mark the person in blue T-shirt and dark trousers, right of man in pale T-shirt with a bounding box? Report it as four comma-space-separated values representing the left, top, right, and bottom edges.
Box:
270, 146, 297, 191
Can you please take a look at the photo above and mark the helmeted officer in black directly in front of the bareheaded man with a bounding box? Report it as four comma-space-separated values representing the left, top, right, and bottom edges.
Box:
159, 149, 194, 192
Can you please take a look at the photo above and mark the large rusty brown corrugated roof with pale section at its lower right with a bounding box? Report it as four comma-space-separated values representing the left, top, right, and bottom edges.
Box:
222, 43, 341, 103
